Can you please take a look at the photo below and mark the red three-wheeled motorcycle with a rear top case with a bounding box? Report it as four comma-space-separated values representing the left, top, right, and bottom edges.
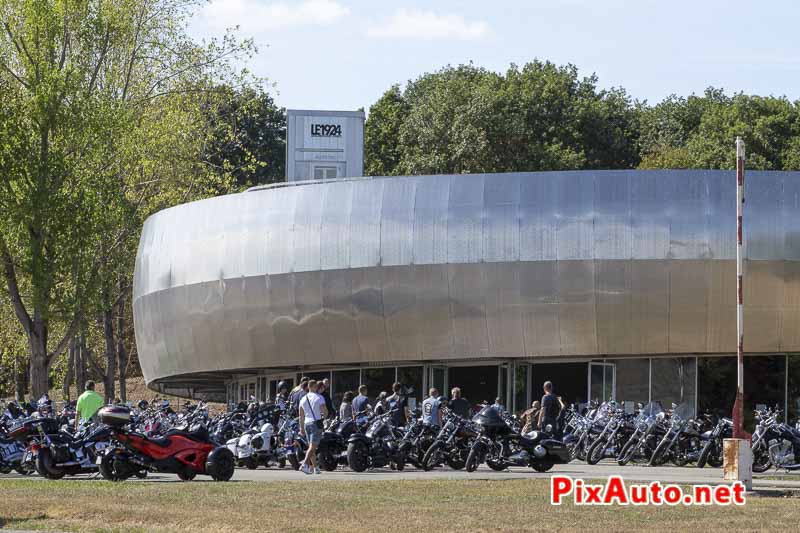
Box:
97, 407, 236, 481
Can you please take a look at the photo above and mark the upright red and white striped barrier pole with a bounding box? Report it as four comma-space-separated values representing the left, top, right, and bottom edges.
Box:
733, 137, 747, 439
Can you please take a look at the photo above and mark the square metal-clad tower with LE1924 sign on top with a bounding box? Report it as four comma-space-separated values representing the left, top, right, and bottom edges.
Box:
286, 109, 364, 181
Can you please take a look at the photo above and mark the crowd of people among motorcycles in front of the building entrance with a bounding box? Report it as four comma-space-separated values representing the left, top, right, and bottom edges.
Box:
275, 377, 566, 474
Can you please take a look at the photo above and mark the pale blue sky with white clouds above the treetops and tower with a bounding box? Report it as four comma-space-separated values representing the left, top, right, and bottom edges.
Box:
191, 0, 800, 109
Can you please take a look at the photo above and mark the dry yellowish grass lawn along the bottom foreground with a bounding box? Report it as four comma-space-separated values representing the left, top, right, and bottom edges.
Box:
0, 479, 800, 533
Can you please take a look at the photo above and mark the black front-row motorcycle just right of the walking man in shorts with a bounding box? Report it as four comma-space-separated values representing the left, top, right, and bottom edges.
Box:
347, 410, 406, 472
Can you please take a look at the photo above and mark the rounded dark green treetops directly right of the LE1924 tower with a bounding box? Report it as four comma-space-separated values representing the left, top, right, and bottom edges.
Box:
365, 61, 639, 175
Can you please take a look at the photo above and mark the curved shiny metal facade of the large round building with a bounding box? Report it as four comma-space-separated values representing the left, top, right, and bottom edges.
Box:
133, 171, 800, 396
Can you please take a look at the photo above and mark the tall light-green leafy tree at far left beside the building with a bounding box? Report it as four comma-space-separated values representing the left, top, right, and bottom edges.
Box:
0, 0, 251, 395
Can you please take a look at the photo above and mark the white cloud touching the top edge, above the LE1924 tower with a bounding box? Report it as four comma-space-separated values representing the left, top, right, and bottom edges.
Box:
200, 0, 350, 33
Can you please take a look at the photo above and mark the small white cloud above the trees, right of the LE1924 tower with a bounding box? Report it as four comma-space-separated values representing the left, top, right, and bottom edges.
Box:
367, 9, 490, 41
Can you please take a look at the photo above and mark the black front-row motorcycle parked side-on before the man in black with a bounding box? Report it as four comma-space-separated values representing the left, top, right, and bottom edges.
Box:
465, 406, 571, 472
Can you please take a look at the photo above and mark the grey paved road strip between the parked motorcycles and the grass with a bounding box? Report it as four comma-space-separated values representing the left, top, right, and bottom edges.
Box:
0, 461, 800, 490
